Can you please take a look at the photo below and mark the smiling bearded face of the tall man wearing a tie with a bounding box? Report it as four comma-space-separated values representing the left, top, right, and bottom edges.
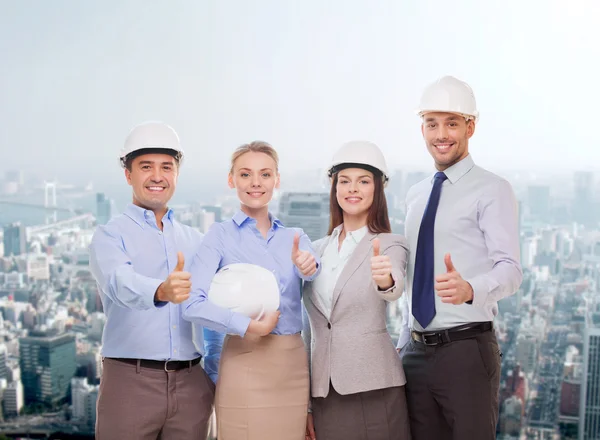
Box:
421, 113, 475, 171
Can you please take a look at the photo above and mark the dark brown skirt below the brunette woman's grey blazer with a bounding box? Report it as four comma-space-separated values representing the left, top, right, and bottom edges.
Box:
312, 384, 410, 440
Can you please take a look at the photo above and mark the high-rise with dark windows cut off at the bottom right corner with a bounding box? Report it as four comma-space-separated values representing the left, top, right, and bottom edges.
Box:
579, 327, 600, 440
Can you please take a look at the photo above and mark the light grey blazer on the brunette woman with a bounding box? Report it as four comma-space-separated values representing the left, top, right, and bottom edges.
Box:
303, 232, 408, 397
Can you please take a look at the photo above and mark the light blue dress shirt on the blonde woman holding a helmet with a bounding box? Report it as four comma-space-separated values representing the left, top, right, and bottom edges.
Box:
183, 211, 321, 336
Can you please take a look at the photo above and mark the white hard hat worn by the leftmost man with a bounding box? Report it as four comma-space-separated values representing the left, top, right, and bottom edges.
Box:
119, 122, 183, 161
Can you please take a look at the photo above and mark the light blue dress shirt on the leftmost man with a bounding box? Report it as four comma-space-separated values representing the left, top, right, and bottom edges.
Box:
90, 204, 224, 381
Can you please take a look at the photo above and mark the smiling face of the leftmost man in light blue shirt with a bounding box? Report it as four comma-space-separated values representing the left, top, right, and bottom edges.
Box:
125, 154, 179, 212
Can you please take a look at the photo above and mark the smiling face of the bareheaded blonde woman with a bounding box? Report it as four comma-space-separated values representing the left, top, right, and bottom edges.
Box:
228, 151, 279, 215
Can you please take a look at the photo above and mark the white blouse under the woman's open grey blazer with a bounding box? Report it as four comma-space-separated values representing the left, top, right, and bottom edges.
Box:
313, 225, 367, 318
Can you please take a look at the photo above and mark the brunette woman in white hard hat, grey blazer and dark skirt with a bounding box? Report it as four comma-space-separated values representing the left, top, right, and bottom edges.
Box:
304, 142, 410, 440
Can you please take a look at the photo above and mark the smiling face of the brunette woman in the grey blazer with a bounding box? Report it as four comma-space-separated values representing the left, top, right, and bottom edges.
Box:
336, 168, 375, 224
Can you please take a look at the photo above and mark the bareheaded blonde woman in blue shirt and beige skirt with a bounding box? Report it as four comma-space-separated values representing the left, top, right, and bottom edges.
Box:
183, 141, 320, 440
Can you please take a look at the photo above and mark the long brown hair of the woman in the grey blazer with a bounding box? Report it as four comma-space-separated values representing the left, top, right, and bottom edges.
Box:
327, 173, 392, 235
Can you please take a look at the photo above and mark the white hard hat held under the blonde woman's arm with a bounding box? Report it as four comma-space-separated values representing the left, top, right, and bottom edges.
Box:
208, 263, 280, 319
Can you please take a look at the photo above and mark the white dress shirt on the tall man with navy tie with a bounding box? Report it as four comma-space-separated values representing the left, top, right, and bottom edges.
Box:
405, 155, 523, 331
